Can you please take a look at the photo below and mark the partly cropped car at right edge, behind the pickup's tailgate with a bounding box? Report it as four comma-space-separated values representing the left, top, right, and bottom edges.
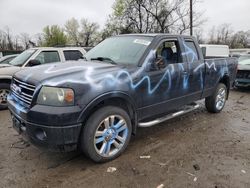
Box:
235, 54, 250, 88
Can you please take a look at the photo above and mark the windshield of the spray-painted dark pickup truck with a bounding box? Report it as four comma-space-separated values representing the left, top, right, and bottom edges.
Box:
85, 36, 153, 65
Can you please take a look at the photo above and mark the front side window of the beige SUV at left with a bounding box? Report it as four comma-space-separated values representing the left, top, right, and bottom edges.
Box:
35, 51, 60, 64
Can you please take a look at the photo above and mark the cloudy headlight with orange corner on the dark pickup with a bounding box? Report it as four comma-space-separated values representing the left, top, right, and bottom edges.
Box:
37, 86, 74, 106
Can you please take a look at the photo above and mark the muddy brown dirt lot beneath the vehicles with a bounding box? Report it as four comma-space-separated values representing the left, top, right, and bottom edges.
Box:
0, 91, 250, 188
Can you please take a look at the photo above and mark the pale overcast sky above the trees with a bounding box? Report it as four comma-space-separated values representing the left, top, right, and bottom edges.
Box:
0, 0, 250, 34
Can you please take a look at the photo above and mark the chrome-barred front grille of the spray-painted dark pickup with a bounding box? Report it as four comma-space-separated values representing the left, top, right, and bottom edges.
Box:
11, 78, 36, 106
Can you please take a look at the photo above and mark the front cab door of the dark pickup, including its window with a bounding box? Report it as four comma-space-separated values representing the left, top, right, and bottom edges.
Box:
140, 37, 187, 118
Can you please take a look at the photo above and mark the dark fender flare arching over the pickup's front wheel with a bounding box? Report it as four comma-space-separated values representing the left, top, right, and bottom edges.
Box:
82, 97, 137, 134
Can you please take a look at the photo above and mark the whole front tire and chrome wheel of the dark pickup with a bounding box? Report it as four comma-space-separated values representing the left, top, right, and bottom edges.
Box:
80, 106, 132, 163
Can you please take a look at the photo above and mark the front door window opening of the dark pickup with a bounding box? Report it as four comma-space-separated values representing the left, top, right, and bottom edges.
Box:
157, 40, 181, 64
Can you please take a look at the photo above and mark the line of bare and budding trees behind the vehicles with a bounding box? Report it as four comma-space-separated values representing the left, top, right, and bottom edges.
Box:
0, 0, 250, 50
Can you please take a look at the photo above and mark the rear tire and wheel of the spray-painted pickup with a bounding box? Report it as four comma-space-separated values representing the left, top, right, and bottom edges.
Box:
205, 83, 227, 113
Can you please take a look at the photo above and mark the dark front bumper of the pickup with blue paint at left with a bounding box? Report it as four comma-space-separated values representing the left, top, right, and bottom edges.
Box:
8, 96, 82, 151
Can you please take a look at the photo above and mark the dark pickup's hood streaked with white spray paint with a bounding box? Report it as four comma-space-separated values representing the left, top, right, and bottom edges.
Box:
14, 61, 130, 85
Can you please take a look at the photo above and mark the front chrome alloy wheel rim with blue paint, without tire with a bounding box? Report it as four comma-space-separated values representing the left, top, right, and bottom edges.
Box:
94, 115, 128, 157
